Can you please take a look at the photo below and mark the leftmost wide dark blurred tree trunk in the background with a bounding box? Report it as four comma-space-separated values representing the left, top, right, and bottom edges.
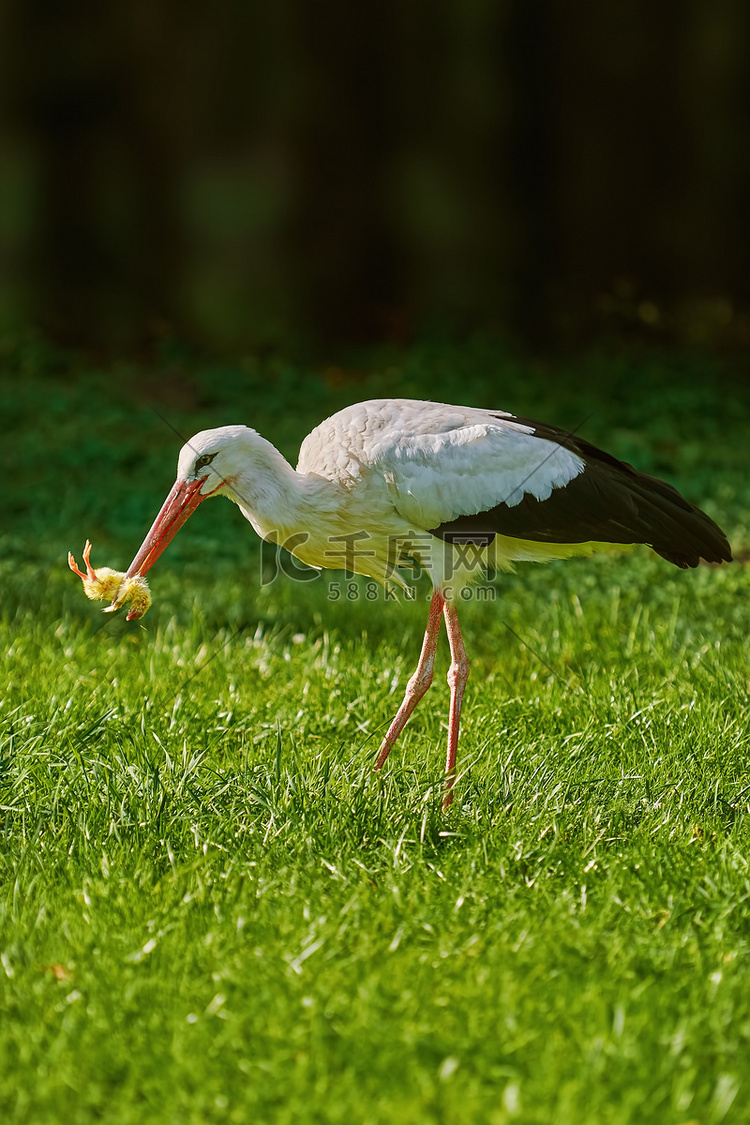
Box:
7, 0, 183, 349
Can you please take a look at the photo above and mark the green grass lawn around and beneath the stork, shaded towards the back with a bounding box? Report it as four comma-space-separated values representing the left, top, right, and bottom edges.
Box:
0, 342, 750, 1125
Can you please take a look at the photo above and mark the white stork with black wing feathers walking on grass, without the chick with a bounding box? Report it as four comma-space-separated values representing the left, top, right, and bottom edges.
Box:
118, 398, 731, 808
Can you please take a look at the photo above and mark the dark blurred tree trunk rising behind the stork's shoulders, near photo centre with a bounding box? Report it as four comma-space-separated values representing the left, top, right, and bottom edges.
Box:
288, 0, 403, 341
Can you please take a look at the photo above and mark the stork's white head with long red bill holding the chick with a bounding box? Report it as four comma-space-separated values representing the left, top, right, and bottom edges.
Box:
127, 425, 258, 577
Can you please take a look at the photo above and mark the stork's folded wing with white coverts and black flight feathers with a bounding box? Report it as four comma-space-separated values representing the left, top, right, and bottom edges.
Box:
382, 415, 731, 567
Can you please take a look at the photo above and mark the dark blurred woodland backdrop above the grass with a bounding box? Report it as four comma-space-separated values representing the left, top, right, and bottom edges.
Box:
0, 0, 750, 353
